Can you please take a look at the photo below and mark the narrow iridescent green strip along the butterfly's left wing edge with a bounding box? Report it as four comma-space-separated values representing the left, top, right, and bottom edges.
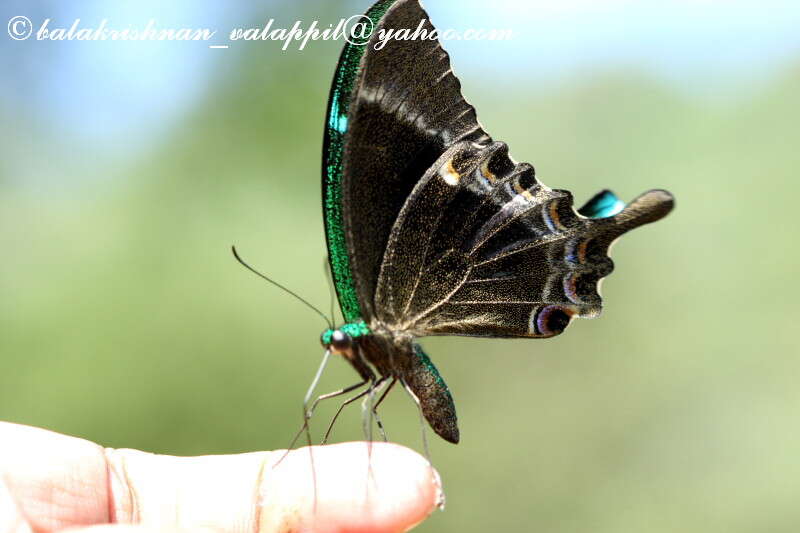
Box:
322, 0, 394, 322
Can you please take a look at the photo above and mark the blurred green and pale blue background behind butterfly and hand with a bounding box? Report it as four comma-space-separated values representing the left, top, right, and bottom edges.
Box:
0, 0, 800, 533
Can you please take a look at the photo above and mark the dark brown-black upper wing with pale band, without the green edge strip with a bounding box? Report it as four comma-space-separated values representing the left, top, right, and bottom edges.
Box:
328, 0, 490, 320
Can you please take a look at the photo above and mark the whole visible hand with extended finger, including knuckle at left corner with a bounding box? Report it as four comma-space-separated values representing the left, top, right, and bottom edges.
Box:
0, 422, 441, 533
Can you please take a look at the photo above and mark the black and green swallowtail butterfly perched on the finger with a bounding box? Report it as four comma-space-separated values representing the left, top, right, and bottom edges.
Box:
314, 0, 674, 443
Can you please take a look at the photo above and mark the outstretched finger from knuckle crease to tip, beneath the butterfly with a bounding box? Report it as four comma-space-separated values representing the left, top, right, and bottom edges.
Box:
109, 442, 441, 533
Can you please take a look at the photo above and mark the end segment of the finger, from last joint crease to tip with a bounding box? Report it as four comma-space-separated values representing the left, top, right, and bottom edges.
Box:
259, 442, 442, 533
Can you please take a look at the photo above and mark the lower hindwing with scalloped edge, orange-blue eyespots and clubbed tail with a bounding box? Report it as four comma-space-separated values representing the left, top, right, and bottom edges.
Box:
375, 137, 673, 337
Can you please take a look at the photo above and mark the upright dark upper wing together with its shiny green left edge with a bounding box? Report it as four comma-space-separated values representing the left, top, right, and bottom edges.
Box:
323, 0, 491, 322
